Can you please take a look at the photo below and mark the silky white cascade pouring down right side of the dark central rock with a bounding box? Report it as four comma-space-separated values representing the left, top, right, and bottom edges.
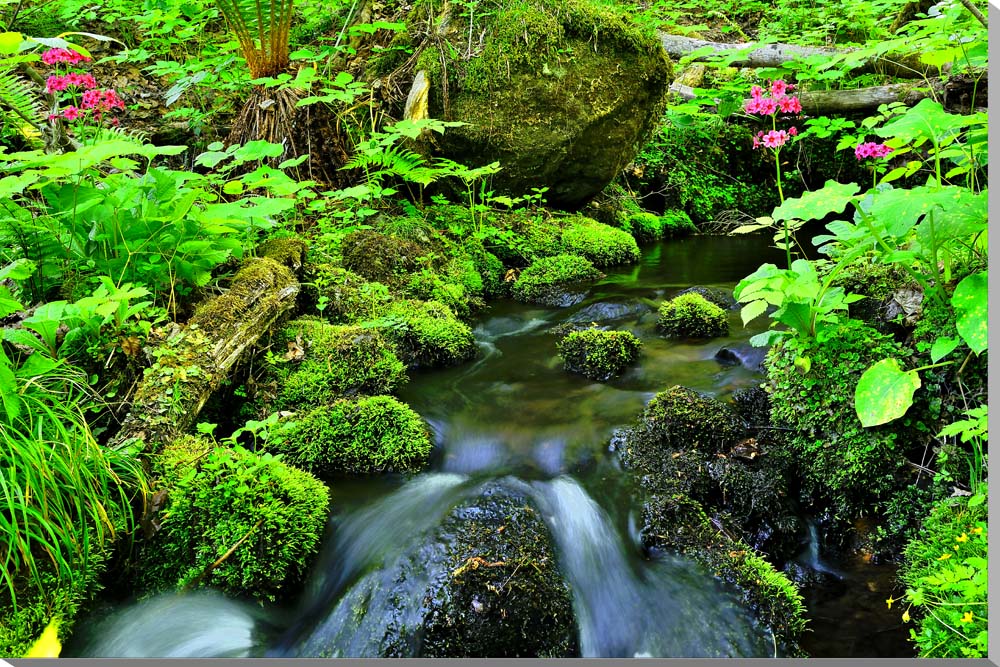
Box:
533, 476, 769, 657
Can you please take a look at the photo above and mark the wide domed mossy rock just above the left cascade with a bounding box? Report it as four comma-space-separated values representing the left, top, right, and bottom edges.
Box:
268, 396, 431, 477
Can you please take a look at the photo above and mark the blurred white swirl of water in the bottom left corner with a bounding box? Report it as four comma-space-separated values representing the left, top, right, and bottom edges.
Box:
66, 591, 263, 658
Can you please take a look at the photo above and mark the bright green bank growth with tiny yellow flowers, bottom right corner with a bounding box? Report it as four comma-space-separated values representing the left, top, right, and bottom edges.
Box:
900, 498, 989, 658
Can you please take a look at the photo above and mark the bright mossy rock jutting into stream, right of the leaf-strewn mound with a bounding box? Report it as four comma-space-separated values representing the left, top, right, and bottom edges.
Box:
380, 299, 476, 368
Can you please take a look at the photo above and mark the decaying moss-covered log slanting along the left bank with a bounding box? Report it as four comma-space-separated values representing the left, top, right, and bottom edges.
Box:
109, 240, 305, 452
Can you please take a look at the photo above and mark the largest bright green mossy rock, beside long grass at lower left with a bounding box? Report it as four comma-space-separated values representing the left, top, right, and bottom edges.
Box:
137, 437, 329, 601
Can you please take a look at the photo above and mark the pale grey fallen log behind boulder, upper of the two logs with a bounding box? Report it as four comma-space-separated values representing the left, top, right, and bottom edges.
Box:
660, 32, 941, 79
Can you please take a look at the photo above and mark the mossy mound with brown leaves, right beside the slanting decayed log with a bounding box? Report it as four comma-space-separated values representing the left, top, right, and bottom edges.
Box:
273, 318, 407, 410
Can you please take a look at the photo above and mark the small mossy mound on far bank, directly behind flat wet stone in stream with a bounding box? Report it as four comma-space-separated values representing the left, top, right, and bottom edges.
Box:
512, 255, 604, 307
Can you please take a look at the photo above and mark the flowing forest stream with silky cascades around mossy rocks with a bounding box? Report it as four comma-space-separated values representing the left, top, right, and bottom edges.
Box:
67, 236, 912, 657
